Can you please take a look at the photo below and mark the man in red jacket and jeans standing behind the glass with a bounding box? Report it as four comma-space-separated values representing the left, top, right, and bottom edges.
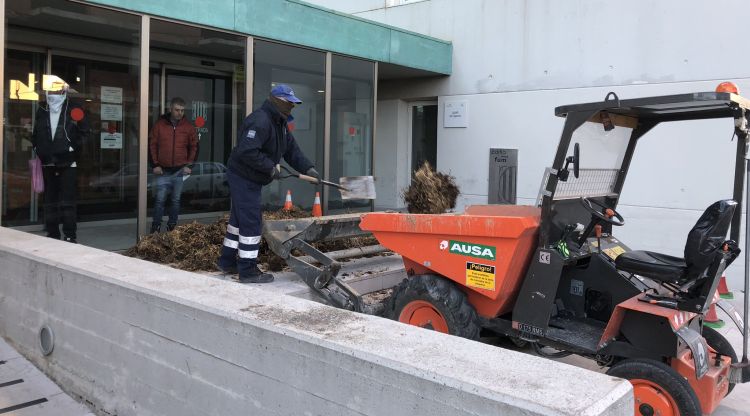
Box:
148, 97, 198, 233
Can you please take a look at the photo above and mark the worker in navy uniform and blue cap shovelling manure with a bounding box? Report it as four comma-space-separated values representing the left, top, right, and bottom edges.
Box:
217, 84, 320, 283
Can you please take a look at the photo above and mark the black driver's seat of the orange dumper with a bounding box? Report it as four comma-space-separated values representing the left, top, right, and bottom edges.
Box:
615, 200, 737, 283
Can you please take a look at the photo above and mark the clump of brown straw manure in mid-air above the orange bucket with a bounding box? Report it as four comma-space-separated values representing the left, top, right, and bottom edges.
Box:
403, 162, 459, 214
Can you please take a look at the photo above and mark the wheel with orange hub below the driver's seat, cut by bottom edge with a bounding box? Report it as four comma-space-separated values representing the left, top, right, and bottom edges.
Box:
607, 358, 703, 416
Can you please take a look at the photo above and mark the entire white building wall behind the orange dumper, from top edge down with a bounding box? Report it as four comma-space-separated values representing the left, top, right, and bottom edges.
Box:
314, 0, 750, 289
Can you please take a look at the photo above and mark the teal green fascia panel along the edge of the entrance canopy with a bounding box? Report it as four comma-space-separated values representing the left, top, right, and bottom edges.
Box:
89, 0, 453, 74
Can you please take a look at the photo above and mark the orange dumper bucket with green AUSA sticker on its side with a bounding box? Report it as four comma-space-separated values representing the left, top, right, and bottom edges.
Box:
360, 205, 541, 318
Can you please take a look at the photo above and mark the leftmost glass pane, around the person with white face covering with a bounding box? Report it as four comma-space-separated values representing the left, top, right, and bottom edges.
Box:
2, 0, 141, 249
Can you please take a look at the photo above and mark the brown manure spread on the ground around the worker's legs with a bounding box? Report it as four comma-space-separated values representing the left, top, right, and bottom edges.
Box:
125, 206, 378, 271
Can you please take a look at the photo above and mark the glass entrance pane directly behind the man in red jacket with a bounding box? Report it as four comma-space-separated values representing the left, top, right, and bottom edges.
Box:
147, 20, 246, 222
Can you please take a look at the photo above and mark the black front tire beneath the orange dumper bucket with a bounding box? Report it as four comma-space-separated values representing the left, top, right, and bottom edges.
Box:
385, 274, 481, 340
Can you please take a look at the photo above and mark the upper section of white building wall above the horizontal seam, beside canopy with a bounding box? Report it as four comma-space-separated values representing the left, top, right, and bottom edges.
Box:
324, 0, 750, 97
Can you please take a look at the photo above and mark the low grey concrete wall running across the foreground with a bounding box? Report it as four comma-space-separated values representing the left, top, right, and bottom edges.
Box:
0, 228, 633, 416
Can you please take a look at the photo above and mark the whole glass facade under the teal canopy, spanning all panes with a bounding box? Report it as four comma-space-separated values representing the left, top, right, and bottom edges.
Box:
0, 0, 375, 250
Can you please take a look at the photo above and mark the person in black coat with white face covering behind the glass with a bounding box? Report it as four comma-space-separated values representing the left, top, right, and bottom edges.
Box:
31, 84, 89, 243
